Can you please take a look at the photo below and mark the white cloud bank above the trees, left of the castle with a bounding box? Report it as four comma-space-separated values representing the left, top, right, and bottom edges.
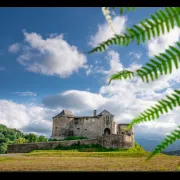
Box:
0, 100, 57, 136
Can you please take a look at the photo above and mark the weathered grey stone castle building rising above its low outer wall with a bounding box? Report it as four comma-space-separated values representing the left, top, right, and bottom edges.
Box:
51, 110, 134, 142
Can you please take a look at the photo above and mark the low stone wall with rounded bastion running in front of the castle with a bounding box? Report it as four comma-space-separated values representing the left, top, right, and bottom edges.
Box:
7, 134, 134, 153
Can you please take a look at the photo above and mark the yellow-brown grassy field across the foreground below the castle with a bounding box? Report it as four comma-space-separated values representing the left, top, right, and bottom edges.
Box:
0, 150, 180, 171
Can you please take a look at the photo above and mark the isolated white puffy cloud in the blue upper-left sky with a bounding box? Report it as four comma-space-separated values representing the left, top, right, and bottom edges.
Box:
17, 31, 86, 78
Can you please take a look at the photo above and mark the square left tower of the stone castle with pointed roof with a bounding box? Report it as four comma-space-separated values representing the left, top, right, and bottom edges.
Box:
51, 110, 74, 139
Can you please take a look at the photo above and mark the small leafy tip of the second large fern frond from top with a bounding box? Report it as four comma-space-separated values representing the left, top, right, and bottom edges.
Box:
109, 70, 134, 84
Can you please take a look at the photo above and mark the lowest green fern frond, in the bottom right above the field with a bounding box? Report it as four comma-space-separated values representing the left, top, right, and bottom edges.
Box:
147, 126, 180, 160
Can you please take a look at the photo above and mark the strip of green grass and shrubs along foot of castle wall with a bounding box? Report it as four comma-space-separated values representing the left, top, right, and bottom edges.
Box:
27, 143, 149, 157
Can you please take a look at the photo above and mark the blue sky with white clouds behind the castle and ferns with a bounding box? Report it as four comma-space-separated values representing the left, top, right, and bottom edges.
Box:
0, 7, 180, 139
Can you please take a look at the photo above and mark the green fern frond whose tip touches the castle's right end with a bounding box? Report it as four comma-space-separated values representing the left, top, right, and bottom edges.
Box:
127, 90, 180, 129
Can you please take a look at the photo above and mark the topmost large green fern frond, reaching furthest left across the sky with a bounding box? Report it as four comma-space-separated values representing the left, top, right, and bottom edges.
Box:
89, 7, 180, 54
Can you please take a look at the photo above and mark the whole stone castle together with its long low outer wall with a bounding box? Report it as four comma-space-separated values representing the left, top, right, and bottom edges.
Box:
7, 110, 135, 153
